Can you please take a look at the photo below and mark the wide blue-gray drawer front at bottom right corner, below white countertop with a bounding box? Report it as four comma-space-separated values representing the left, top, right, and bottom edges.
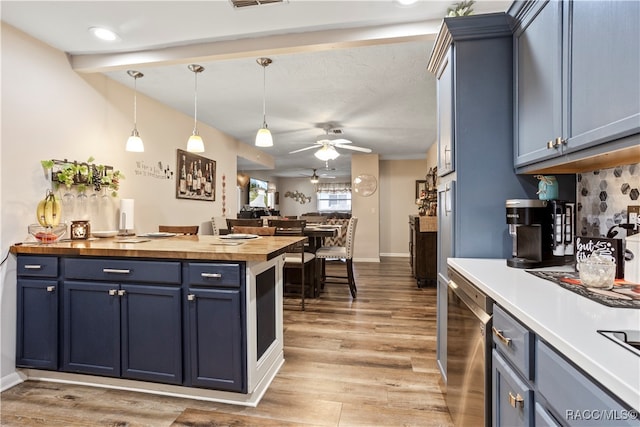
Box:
536, 340, 638, 427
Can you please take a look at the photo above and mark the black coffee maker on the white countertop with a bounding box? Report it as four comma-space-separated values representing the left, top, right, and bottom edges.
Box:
506, 199, 575, 268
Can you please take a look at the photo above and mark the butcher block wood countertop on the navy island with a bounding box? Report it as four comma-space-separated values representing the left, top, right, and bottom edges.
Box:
11, 235, 306, 261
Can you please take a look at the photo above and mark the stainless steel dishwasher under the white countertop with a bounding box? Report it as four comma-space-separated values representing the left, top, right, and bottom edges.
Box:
446, 268, 493, 426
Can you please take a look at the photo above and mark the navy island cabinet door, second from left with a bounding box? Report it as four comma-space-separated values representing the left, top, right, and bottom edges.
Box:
63, 281, 120, 377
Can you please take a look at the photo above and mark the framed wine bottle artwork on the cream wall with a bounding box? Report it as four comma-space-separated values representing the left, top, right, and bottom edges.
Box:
176, 149, 216, 202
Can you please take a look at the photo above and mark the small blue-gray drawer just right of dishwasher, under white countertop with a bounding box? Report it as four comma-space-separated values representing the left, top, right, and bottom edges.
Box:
493, 305, 533, 380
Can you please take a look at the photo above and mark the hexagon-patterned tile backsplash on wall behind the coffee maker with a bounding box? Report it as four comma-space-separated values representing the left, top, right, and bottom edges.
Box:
576, 163, 640, 236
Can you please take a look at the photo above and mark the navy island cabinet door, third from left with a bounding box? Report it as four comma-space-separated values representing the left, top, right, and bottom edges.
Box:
119, 285, 182, 384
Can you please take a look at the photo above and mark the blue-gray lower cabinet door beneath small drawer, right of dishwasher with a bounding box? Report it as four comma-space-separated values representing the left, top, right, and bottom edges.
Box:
492, 349, 534, 427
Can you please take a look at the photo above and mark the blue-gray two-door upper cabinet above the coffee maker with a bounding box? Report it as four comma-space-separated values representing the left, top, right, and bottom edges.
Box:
509, 1, 640, 172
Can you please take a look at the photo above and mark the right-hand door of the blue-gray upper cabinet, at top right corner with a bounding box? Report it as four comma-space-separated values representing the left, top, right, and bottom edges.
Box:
563, 0, 640, 153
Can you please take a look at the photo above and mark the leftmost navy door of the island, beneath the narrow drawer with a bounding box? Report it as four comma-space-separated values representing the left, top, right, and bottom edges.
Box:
16, 279, 59, 370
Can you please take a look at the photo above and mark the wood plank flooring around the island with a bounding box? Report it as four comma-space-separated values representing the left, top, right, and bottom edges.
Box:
0, 258, 452, 427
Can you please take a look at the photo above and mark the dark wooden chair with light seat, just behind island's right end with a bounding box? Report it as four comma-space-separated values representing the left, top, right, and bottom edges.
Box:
269, 219, 317, 310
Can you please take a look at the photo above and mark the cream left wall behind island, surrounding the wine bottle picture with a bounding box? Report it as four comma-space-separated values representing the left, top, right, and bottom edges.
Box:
0, 23, 254, 388
